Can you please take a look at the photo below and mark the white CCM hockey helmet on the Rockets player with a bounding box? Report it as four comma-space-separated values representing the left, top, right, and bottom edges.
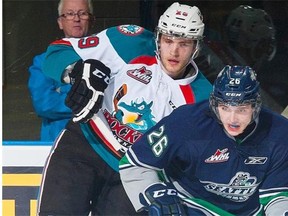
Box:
155, 2, 204, 57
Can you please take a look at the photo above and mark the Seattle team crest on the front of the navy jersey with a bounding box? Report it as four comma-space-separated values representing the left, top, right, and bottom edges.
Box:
201, 172, 259, 202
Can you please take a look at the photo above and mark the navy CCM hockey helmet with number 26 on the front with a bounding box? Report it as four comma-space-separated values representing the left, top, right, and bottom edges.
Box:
209, 65, 262, 122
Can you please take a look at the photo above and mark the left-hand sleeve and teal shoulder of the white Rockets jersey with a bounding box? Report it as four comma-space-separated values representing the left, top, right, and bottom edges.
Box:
43, 25, 156, 82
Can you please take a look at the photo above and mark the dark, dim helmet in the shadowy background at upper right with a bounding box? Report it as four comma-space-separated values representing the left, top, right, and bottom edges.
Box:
225, 5, 276, 61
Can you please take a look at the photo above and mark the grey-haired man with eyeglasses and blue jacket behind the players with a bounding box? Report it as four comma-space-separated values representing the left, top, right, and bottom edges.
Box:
28, 0, 94, 141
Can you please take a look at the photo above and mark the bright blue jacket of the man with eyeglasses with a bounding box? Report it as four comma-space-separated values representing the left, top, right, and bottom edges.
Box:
28, 53, 72, 141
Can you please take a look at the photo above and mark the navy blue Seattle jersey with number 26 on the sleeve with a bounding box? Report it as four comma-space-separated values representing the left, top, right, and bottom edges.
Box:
120, 101, 288, 215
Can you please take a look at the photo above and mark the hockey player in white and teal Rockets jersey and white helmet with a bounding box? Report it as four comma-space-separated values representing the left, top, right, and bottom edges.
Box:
38, 3, 212, 215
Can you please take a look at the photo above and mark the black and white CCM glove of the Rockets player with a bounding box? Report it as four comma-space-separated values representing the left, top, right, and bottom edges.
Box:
65, 59, 110, 122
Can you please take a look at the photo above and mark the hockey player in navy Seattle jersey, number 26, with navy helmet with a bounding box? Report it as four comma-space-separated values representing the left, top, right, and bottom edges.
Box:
120, 66, 288, 216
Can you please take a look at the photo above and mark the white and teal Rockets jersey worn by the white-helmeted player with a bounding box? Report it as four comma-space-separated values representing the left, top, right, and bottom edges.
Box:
42, 25, 212, 170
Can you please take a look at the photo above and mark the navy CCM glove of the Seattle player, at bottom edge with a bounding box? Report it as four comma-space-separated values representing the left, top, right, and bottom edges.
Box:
139, 183, 186, 216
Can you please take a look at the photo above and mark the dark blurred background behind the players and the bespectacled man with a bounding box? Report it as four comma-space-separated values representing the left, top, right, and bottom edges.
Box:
2, 0, 288, 140
